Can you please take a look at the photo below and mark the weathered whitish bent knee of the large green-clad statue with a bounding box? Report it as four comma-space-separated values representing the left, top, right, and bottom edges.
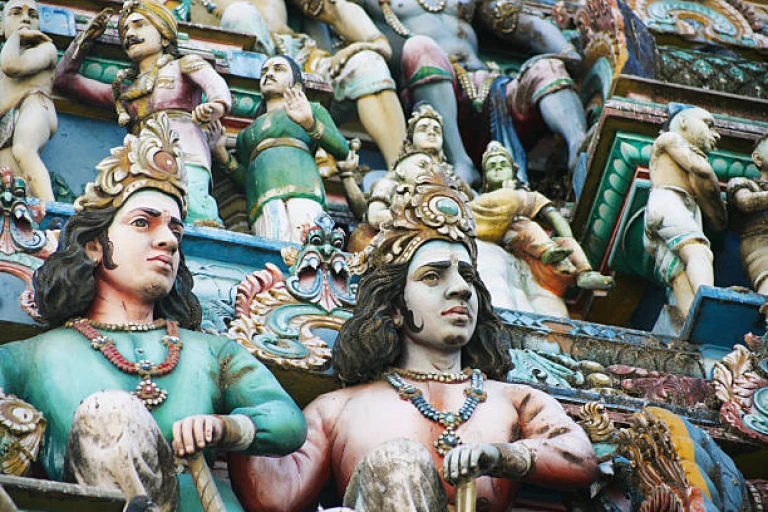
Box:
67, 390, 179, 512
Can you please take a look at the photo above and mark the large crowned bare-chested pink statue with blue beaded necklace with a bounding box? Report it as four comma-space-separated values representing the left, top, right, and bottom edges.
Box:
230, 173, 596, 512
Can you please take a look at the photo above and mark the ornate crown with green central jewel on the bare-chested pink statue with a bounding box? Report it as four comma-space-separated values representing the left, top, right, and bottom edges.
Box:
350, 172, 477, 274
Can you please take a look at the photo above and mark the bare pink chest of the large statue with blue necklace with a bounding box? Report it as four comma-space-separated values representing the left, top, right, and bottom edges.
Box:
305, 381, 539, 511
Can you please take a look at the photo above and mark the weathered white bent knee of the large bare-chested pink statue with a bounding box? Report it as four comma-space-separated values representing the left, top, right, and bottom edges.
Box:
344, 439, 448, 512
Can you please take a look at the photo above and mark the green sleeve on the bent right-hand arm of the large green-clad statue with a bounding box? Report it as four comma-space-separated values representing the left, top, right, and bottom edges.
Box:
219, 341, 307, 456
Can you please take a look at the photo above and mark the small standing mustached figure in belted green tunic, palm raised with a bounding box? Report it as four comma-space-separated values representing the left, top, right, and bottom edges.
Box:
213, 55, 350, 243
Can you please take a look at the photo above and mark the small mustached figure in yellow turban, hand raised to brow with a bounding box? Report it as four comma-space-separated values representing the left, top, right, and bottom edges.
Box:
56, 0, 232, 226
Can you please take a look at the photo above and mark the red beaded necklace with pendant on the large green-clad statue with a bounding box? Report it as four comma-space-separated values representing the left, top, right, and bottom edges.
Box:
65, 318, 183, 410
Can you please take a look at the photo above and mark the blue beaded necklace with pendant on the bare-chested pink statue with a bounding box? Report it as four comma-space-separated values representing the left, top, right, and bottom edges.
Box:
386, 370, 486, 457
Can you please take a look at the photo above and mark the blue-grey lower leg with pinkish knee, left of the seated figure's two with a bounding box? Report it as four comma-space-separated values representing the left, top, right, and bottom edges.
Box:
402, 36, 482, 187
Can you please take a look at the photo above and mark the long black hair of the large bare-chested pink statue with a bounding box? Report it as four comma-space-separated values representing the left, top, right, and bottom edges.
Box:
333, 262, 511, 385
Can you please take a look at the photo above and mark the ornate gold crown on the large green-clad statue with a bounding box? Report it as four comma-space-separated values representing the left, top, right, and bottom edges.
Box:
75, 113, 187, 217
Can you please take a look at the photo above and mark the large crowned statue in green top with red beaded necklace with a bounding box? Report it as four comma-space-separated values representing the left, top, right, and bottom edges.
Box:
0, 115, 306, 512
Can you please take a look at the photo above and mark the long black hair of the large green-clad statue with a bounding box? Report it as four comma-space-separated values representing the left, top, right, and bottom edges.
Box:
32, 208, 202, 330
